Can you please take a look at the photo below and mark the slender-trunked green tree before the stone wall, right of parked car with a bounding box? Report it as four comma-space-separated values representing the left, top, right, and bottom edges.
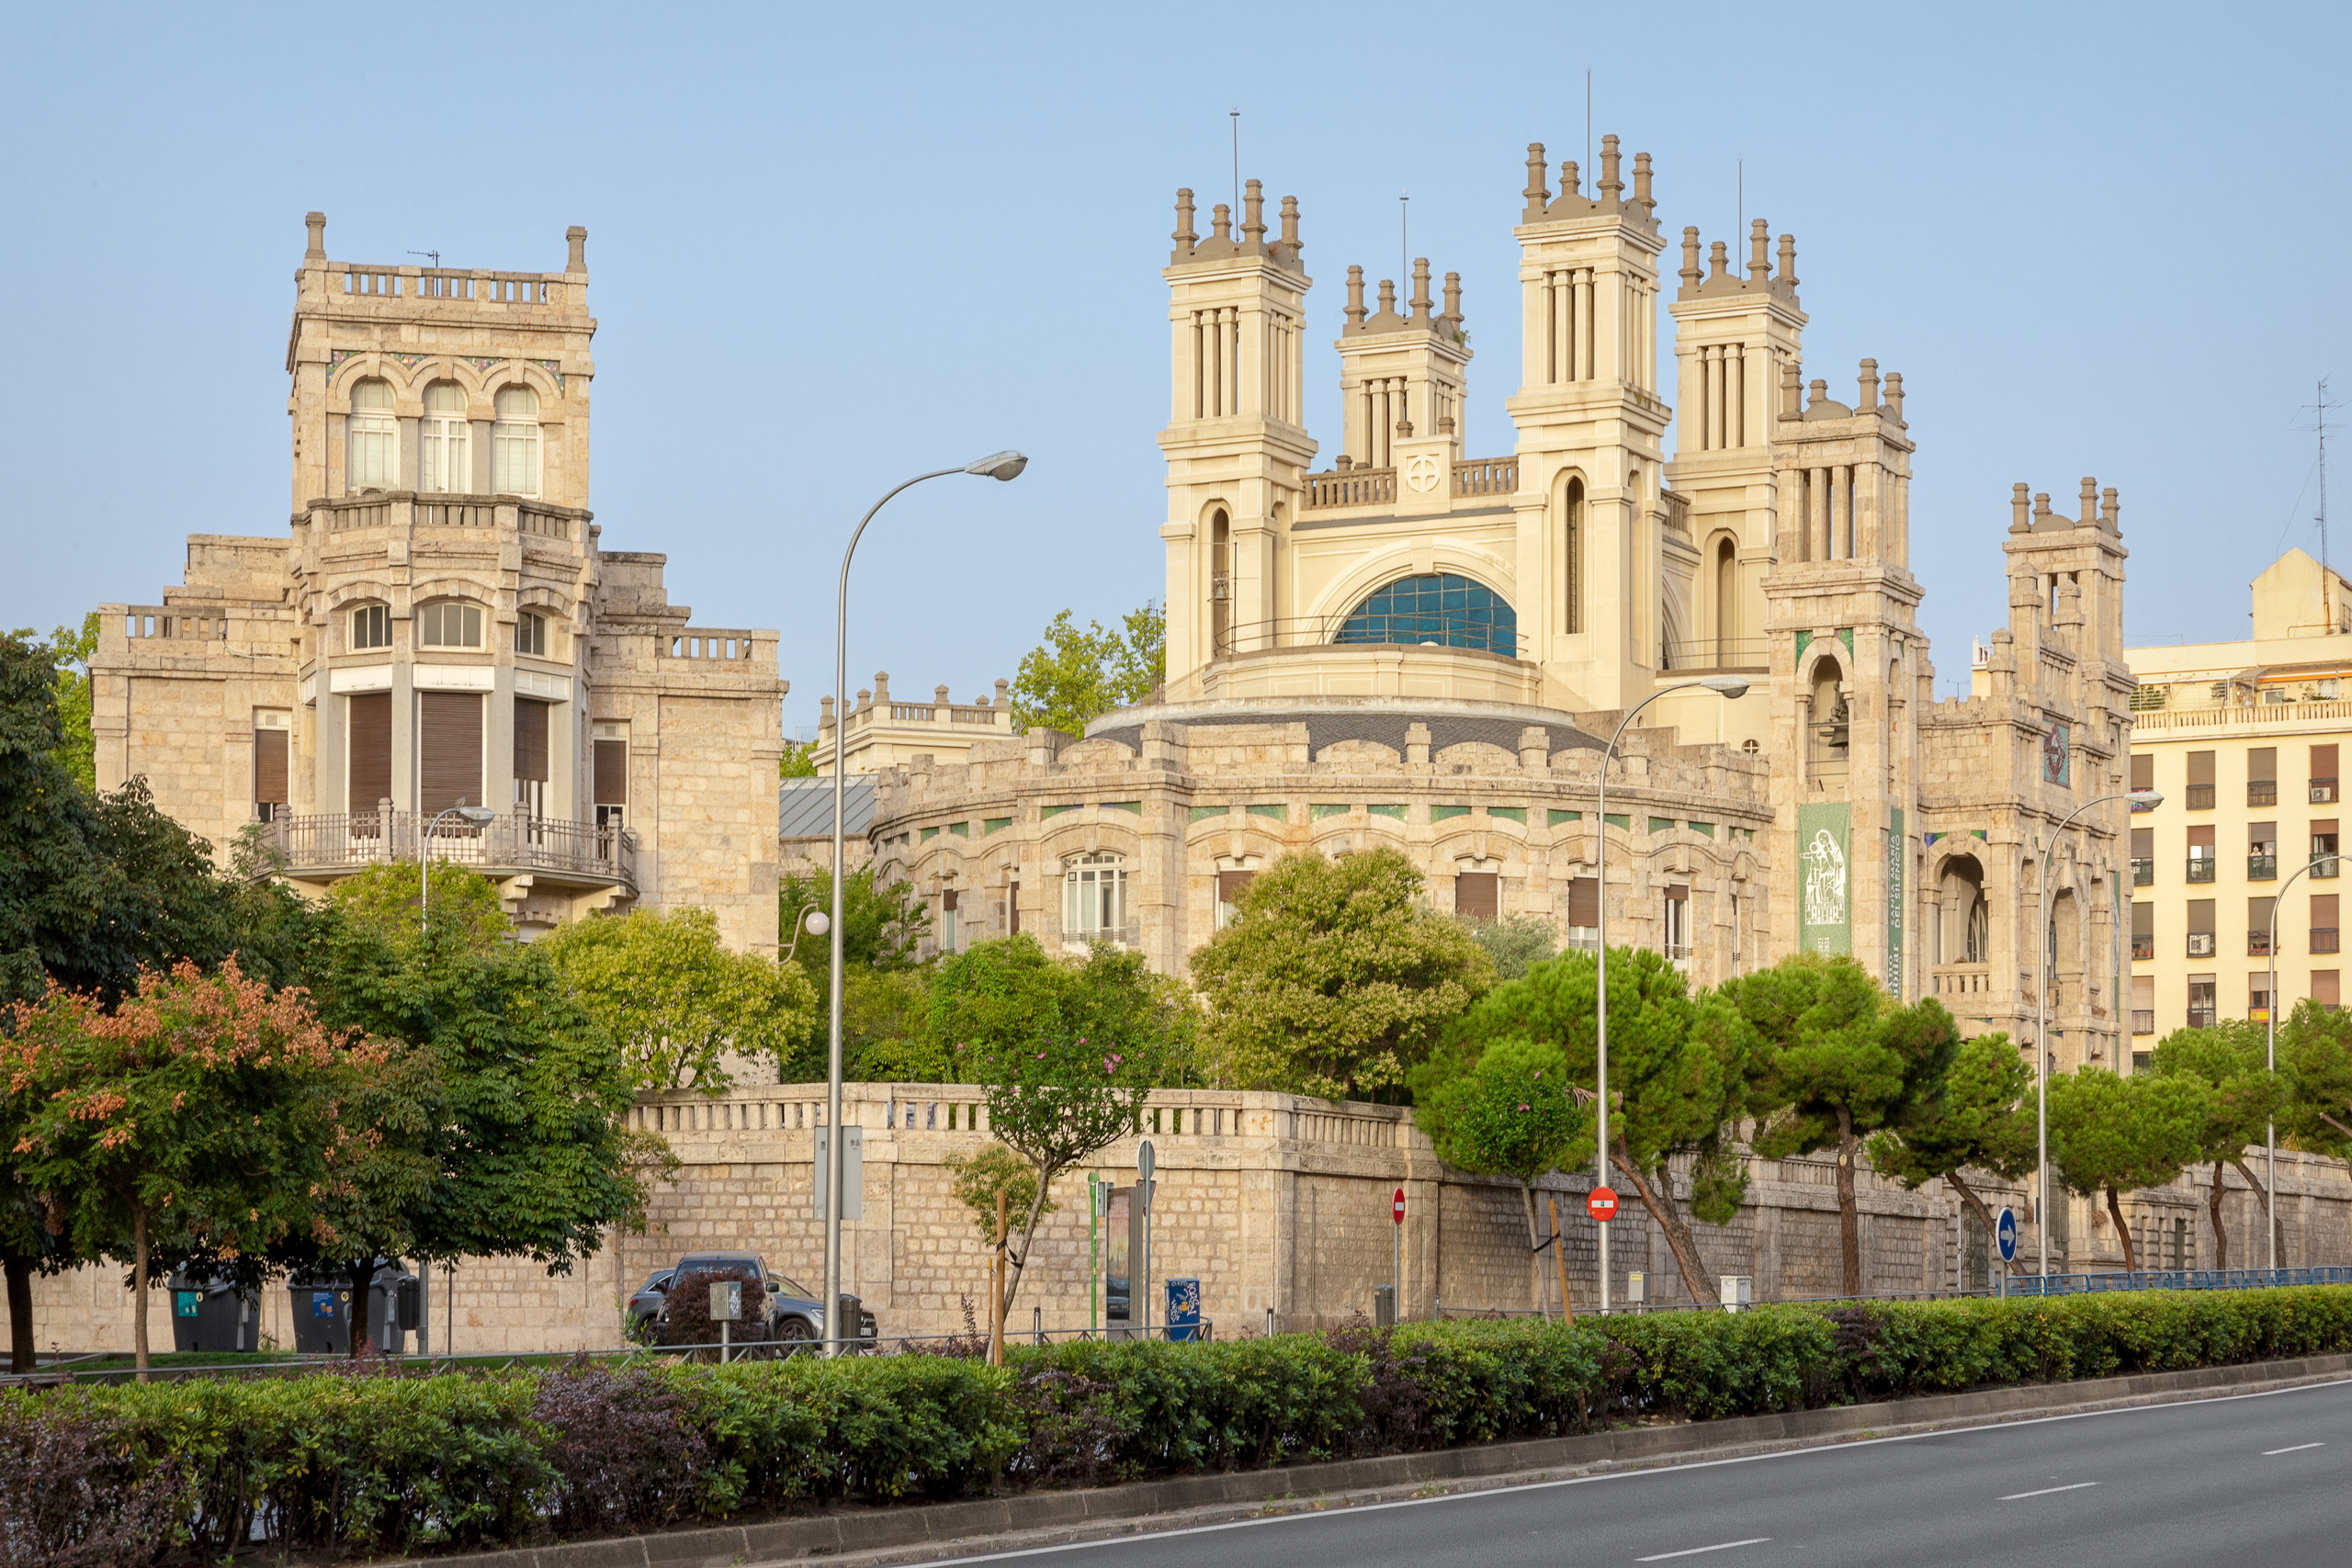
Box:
932, 936, 1193, 1312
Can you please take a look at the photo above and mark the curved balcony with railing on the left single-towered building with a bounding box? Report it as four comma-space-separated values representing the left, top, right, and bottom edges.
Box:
268, 811, 638, 898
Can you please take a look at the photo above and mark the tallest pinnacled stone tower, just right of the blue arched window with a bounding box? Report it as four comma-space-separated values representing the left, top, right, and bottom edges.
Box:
1505, 136, 1689, 710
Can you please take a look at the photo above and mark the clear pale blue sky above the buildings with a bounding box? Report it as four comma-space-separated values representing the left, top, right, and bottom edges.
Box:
0, 5, 2352, 727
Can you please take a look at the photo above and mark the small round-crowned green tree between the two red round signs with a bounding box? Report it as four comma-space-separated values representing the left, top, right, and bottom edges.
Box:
1414, 1034, 1592, 1312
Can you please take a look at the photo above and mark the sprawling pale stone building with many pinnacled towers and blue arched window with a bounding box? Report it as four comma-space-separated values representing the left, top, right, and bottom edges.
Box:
870, 136, 2131, 1081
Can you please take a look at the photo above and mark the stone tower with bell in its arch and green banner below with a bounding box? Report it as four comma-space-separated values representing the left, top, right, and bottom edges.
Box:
1764, 359, 1933, 997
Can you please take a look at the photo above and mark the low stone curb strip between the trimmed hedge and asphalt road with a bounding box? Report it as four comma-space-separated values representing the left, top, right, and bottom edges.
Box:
404, 1357, 2352, 1568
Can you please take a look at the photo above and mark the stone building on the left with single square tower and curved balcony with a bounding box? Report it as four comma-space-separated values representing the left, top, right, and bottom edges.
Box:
89, 211, 786, 952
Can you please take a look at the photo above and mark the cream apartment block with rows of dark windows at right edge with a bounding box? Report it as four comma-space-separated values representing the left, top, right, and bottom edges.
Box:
2131, 550, 2352, 1054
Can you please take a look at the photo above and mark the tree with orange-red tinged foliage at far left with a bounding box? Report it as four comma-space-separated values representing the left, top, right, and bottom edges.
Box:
0, 959, 383, 1380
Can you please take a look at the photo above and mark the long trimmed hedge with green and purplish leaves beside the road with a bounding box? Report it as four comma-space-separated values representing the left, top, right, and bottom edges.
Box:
14, 1286, 2352, 1568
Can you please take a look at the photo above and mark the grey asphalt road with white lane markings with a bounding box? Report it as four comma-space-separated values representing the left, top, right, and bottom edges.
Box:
931, 1382, 2352, 1568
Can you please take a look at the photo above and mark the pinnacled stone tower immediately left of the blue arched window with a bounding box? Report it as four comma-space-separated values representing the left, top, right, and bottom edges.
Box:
1159, 181, 1315, 689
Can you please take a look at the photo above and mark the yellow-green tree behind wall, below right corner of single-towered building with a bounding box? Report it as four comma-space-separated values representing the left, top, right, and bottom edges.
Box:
537, 908, 816, 1096
